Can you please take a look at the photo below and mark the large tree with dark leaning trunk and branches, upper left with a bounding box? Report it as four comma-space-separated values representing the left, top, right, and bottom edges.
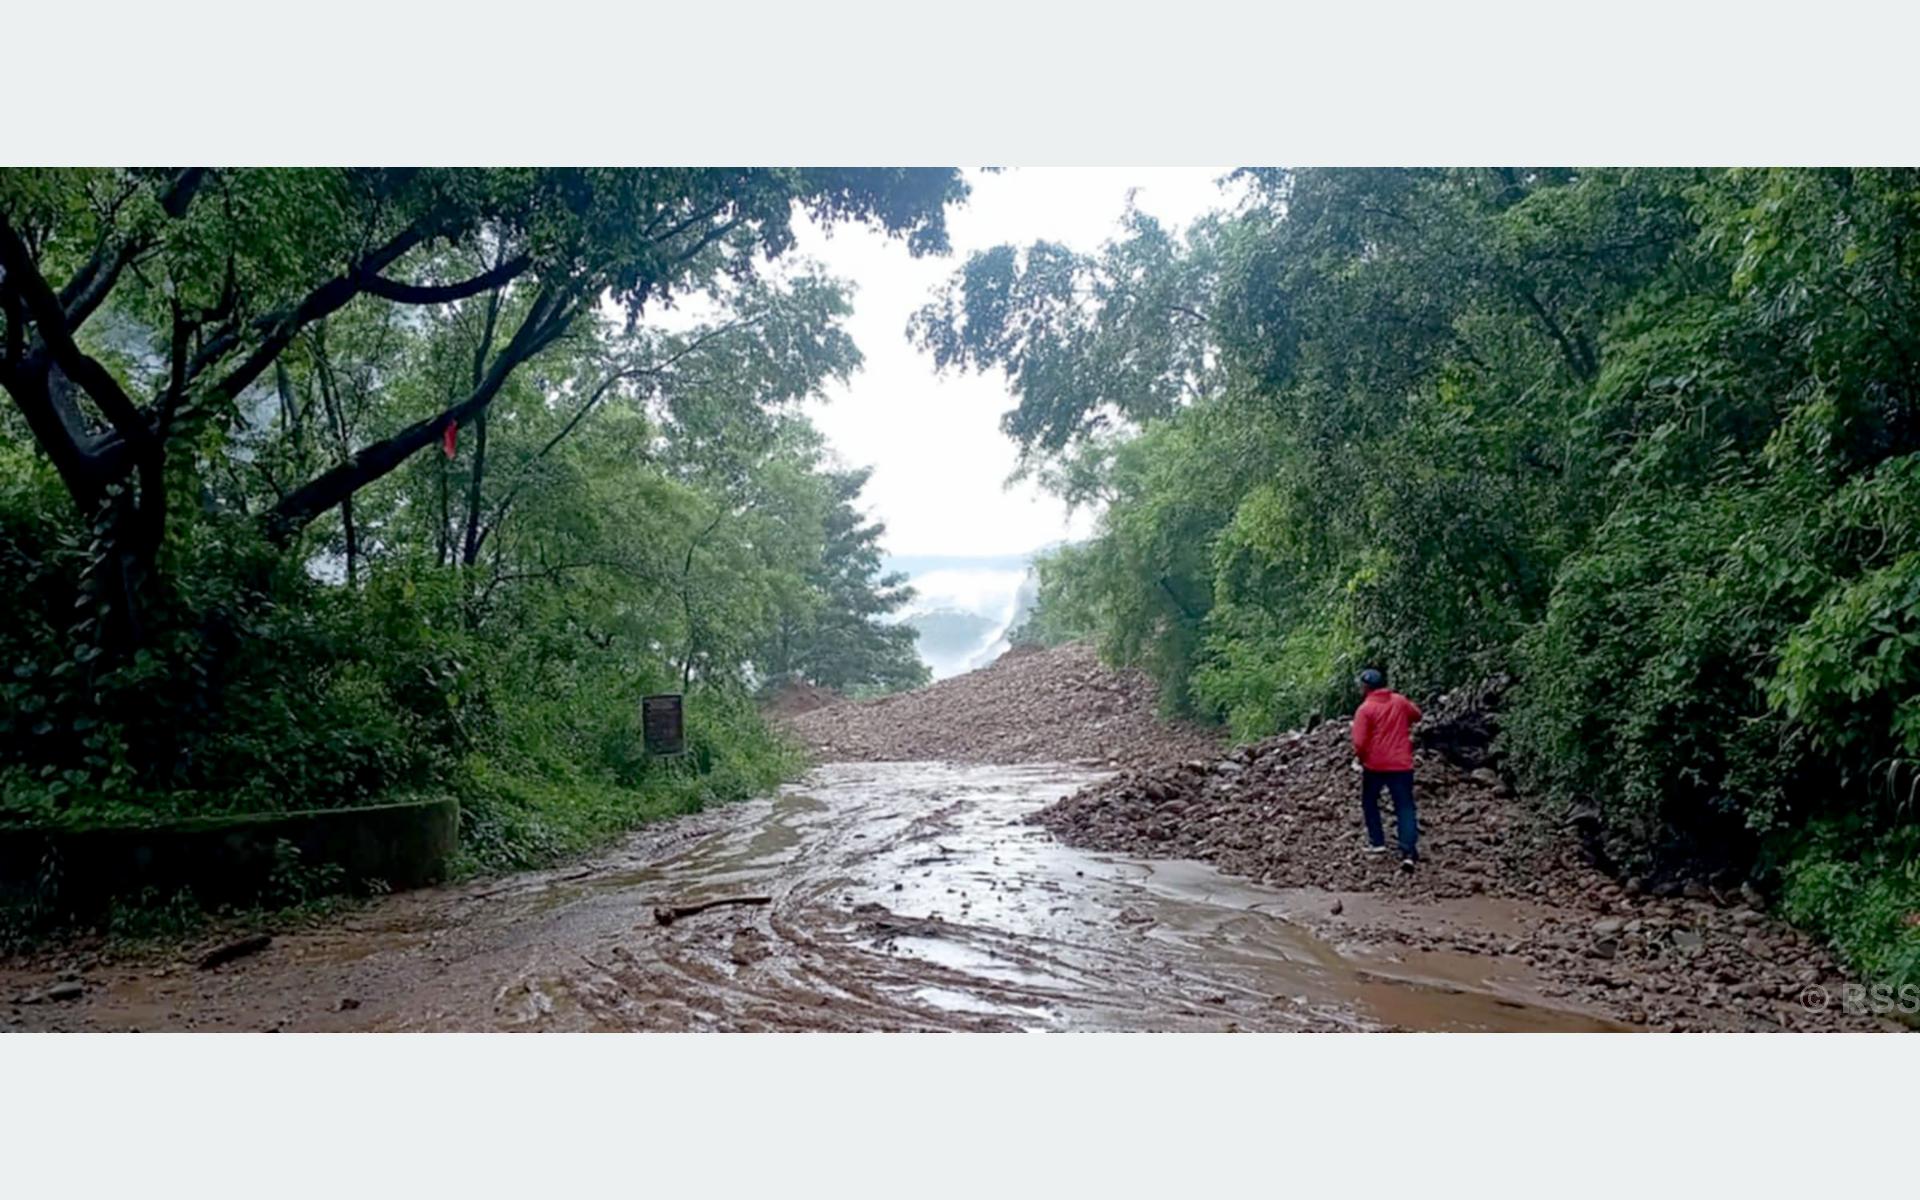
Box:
0, 169, 962, 643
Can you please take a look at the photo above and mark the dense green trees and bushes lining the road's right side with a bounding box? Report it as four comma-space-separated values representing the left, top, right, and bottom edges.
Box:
936, 169, 1920, 983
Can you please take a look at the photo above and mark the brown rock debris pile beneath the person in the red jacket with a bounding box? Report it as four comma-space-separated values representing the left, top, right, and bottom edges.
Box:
1029, 689, 1885, 1029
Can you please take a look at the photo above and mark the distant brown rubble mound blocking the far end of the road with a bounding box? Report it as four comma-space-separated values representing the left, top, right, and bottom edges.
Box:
787, 643, 1223, 768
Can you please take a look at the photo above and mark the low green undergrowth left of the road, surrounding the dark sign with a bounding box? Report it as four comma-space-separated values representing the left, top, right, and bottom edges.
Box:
0, 441, 797, 866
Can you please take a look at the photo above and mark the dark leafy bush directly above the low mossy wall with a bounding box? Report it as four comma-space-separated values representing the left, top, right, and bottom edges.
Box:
0, 461, 465, 822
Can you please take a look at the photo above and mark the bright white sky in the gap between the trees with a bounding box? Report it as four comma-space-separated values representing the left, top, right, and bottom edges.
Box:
797, 167, 1227, 555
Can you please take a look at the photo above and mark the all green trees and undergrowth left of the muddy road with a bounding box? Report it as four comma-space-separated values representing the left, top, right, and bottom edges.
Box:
0, 169, 964, 920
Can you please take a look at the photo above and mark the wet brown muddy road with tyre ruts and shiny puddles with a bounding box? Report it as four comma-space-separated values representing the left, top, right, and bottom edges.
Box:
0, 762, 1617, 1031
